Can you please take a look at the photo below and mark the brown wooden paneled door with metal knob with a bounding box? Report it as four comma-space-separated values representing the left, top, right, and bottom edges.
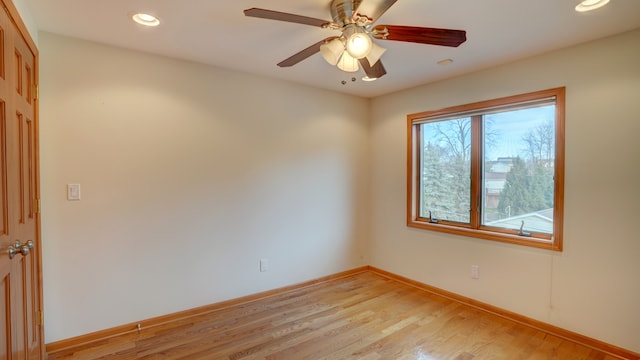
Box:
0, 0, 44, 360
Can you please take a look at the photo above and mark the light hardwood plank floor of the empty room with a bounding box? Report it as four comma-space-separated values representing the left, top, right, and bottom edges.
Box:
49, 272, 615, 360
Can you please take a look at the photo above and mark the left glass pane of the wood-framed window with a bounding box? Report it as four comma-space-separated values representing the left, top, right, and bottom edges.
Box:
419, 117, 471, 223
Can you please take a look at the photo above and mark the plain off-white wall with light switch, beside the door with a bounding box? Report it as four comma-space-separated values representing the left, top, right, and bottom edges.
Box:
40, 33, 370, 343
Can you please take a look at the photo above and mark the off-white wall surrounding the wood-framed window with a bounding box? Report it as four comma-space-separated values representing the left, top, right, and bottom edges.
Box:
370, 30, 640, 351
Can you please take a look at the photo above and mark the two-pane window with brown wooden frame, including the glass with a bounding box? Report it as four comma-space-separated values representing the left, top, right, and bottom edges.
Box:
407, 88, 565, 251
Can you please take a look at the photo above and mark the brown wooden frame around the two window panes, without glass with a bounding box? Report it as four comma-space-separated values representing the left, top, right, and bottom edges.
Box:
407, 87, 565, 251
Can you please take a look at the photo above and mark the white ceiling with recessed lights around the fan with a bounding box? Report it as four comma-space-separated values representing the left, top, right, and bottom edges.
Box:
26, 0, 640, 97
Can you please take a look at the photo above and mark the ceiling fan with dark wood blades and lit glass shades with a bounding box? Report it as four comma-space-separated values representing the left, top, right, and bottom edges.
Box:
244, 0, 467, 80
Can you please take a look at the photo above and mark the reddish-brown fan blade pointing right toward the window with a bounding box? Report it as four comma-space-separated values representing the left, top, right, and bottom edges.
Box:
372, 25, 467, 47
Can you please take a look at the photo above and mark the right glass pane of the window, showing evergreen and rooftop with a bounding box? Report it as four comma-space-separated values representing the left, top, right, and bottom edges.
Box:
481, 105, 555, 234
